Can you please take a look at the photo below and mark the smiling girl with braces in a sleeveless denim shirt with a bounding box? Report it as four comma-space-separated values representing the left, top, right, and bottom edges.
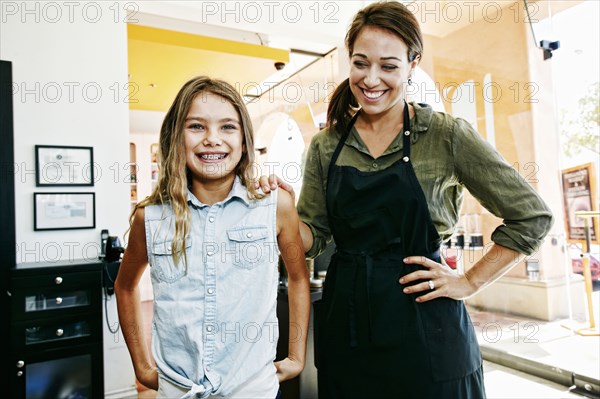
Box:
115, 77, 310, 398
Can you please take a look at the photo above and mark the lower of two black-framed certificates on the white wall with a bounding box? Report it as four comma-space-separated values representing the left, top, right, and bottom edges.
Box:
33, 193, 96, 231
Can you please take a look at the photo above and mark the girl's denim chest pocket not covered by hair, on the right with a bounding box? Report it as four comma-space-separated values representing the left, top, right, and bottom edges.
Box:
227, 226, 275, 269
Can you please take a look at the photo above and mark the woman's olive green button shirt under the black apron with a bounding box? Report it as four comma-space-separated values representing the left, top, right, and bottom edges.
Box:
298, 103, 553, 258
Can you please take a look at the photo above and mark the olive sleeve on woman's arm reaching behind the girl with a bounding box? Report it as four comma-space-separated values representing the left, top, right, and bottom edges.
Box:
297, 132, 331, 258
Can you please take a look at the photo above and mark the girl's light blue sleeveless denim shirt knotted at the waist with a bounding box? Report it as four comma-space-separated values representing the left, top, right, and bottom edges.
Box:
145, 178, 279, 398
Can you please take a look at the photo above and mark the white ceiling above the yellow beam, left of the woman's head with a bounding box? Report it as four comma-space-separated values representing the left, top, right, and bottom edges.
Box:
134, 1, 371, 54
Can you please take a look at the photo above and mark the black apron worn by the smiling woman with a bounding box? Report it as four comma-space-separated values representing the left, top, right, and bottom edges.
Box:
315, 103, 485, 399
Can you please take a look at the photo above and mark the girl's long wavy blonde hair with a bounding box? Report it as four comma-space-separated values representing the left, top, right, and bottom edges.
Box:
130, 76, 263, 263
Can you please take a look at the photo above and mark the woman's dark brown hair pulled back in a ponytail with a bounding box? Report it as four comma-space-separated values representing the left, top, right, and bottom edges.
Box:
327, 1, 423, 132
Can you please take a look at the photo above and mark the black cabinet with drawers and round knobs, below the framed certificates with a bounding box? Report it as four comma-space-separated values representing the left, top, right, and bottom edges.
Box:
9, 260, 104, 399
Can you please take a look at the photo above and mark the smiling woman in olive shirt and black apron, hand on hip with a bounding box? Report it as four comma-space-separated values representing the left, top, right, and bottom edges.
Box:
262, 2, 552, 399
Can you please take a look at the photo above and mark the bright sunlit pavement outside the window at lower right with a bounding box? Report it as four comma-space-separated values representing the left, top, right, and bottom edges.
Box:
469, 291, 600, 397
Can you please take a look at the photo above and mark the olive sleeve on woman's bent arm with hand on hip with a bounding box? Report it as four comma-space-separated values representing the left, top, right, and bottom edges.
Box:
452, 119, 553, 255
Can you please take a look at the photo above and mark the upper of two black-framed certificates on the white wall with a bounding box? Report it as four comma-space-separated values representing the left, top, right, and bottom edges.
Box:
35, 145, 94, 187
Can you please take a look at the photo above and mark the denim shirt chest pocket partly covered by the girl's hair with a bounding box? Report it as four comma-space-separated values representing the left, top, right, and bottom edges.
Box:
150, 237, 192, 283
